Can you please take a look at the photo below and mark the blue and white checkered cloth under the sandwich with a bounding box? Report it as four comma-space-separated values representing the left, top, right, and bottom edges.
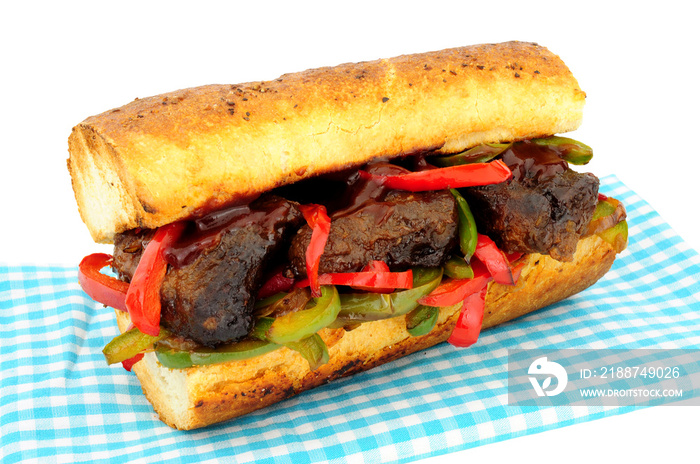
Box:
0, 177, 700, 464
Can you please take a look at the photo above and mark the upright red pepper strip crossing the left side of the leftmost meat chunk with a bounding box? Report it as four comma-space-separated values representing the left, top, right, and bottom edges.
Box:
126, 222, 185, 336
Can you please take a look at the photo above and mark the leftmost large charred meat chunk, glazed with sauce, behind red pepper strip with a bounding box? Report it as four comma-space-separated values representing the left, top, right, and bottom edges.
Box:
113, 197, 303, 346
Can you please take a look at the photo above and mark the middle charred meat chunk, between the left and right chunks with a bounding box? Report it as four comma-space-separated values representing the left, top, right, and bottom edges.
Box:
289, 190, 458, 277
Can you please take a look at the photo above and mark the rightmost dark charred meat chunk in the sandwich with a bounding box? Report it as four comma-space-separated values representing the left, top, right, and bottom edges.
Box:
462, 166, 599, 261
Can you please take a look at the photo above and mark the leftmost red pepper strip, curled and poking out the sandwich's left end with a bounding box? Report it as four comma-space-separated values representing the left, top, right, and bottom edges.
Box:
78, 253, 129, 311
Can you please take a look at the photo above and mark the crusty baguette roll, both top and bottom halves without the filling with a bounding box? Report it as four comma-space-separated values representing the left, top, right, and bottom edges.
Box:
68, 42, 615, 429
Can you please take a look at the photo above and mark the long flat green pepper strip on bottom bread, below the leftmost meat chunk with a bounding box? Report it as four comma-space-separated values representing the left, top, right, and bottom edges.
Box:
156, 340, 280, 369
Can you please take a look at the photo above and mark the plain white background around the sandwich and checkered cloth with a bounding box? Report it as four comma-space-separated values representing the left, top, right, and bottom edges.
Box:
0, 1, 700, 463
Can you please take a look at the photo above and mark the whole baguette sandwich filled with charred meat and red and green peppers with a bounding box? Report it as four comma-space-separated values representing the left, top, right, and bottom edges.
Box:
68, 42, 627, 429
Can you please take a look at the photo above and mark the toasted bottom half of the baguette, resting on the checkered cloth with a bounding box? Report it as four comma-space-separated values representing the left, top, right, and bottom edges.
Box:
117, 236, 615, 430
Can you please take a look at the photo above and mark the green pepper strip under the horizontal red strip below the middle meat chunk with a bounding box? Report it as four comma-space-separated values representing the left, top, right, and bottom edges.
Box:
330, 268, 442, 328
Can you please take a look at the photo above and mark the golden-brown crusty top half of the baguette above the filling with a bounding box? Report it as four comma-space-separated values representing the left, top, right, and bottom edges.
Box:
68, 42, 585, 243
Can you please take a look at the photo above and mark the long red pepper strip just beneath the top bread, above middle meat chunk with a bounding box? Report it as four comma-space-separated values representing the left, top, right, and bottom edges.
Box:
360, 160, 513, 192
